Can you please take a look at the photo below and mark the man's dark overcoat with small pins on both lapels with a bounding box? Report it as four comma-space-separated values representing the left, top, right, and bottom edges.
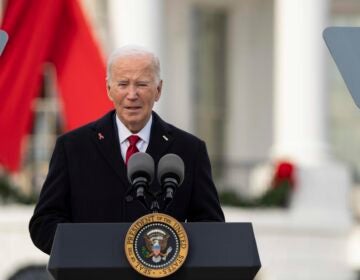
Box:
29, 111, 224, 253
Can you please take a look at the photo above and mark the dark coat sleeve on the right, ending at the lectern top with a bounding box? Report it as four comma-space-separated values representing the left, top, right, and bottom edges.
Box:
187, 141, 225, 222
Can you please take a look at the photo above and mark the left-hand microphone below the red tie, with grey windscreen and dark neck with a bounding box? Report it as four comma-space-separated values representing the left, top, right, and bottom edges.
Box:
127, 152, 155, 202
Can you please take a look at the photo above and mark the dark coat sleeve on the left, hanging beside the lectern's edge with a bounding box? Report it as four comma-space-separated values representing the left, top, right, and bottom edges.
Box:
29, 138, 71, 254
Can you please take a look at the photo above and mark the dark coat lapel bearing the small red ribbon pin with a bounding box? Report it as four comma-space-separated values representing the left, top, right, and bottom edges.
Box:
92, 111, 127, 185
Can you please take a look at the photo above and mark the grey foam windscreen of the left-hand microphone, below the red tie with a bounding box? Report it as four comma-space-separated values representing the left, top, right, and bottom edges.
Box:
127, 152, 155, 184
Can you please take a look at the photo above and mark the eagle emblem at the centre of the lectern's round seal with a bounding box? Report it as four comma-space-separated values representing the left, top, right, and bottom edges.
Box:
142, 229, 172, 263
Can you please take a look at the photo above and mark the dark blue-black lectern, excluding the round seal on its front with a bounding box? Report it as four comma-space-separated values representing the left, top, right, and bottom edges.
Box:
48, 223, 261, 280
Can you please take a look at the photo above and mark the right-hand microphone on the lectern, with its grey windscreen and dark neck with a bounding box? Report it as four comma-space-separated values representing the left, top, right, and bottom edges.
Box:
157, 154, 185, 204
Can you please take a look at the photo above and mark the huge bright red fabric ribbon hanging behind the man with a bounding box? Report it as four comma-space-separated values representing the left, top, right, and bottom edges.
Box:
0, 0, 111, 171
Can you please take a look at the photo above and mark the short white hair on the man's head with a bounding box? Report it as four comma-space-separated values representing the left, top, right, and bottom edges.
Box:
106, 45, 161, 83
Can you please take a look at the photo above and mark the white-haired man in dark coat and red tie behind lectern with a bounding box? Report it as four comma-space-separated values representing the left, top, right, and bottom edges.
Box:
29, 47, 224, 254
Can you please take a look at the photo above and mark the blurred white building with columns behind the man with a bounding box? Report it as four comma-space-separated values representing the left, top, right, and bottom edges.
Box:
0, 0, 360, 280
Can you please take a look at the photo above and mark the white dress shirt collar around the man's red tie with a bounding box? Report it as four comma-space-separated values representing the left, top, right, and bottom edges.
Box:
116, 115, 152, 162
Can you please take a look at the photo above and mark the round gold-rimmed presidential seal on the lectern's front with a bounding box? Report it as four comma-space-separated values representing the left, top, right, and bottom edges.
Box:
125, 213, 189, 278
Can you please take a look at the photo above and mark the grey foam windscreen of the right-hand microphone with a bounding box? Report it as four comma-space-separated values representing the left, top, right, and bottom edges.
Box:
157, 154, 185, 186
